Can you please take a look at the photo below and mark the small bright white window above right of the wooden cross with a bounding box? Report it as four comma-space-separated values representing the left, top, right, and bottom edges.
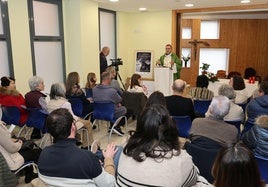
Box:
200, 20, 220, 39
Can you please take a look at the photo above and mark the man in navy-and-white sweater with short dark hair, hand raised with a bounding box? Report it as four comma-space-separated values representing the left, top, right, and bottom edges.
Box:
38, 108, 117, 187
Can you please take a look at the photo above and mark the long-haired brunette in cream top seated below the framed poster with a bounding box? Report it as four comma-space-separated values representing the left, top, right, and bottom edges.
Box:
127, 73, 148, 95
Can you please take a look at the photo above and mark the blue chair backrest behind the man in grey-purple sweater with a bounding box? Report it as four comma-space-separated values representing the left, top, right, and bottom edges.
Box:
93, 101, 115, 122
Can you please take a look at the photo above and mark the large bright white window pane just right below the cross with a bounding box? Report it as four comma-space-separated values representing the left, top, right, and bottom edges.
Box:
199, 48, 229, 75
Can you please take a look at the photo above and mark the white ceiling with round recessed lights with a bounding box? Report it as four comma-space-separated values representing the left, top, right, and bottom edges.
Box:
95, 0, 268, 12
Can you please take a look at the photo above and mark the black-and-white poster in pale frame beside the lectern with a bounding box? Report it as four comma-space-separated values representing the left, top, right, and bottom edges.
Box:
135, 51, 154, 79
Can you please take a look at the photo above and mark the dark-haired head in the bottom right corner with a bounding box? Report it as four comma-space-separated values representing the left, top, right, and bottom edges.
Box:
212, 143, 265, 187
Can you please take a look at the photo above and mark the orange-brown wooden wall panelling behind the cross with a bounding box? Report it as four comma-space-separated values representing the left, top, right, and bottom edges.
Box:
181, 19, 268, 85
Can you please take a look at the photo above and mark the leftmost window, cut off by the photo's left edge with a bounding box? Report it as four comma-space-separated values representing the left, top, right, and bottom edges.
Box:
0, 0, 14, 77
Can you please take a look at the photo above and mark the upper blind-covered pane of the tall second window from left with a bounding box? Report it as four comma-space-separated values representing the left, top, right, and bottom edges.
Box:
33, 1, 60, 36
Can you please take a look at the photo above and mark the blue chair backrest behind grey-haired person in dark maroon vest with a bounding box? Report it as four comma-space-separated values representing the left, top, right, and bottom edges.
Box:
26, 108, 48, 132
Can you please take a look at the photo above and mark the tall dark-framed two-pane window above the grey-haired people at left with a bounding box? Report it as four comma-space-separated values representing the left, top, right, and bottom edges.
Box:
28, 0, 66, 91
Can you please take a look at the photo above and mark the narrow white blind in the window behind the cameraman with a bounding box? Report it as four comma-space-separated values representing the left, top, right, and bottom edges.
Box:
100, 11, 116, 64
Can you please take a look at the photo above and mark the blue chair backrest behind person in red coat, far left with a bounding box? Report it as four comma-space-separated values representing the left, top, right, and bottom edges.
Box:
1, 106, 20, 125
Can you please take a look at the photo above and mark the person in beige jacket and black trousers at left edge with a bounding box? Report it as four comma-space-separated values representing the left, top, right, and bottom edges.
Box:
0, 121, 41, 183
